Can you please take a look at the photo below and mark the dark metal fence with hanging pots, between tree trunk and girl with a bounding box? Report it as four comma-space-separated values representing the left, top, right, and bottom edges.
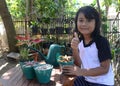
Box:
14, 18, 74, 43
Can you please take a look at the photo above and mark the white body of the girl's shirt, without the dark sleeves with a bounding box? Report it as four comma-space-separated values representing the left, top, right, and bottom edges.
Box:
78, 40, 114, 85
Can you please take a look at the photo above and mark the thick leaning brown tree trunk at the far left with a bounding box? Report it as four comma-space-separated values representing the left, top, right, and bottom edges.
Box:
0, 0, 18, 52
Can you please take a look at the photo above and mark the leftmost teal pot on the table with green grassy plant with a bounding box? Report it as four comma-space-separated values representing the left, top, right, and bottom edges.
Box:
19, 48, 37, 79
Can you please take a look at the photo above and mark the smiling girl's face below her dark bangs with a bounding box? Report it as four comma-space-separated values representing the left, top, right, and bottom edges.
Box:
77, 13, 95, 36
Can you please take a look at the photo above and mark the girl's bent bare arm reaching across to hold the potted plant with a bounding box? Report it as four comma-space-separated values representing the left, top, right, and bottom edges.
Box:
63, 59, 110, 76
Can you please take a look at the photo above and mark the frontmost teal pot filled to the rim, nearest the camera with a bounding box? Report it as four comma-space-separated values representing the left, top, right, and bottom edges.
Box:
34, 64, 53, 84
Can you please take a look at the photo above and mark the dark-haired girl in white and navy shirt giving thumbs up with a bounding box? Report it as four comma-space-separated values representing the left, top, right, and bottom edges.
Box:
63, 6, 114, 86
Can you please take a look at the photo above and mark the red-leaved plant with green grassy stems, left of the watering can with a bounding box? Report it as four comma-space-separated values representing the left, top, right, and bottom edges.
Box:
16, 34, 44, 60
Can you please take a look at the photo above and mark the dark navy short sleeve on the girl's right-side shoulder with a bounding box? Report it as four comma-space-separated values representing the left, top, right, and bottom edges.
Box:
96, 37, 112, 62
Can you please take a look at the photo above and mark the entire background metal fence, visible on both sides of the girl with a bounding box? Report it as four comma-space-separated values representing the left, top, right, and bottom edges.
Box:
14, 17, 120, 43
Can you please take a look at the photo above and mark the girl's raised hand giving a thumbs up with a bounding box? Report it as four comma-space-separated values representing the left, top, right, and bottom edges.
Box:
71, 32, 80, 50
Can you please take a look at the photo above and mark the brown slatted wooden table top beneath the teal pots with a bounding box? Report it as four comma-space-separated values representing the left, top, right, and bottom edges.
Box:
0, 65, 62, 86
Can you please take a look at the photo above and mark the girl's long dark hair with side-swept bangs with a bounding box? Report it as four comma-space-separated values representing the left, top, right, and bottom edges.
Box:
74, 6, 101, 39
